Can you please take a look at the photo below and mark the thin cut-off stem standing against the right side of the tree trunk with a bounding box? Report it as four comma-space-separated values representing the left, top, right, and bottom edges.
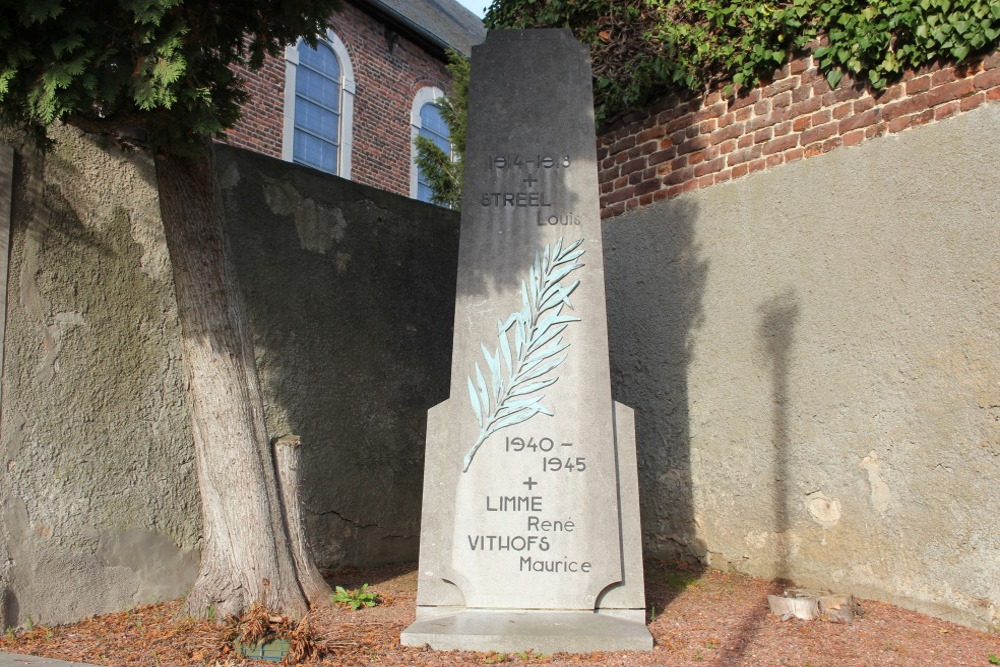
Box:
274, 435, 332, 606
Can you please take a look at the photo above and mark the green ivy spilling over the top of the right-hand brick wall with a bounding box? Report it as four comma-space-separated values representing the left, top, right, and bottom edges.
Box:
486, 0, 1000, 119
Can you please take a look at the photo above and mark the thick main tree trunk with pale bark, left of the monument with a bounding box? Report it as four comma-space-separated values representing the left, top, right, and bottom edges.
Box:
157, 143, 307, 622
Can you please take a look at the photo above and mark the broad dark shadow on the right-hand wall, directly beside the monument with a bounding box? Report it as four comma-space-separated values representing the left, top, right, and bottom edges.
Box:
604, 200, 708, 562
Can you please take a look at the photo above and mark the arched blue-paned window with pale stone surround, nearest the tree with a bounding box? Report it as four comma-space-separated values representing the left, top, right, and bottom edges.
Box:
282, 30, 354, 178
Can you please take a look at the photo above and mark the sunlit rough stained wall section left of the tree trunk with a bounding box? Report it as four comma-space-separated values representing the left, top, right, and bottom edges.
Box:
0, 130, 200, 626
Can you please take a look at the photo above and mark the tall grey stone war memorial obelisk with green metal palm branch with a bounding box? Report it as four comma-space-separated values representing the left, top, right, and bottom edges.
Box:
402, 30, 652, 653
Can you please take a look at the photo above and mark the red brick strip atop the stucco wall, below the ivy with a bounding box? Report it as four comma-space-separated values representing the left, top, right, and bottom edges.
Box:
597, 52, 1000, 218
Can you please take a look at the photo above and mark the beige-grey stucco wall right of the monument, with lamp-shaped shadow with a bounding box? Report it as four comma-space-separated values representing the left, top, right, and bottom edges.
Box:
605, 104, 1000, 628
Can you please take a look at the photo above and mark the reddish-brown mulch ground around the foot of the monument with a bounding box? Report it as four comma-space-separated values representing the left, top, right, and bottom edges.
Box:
0, 561, 1000, 667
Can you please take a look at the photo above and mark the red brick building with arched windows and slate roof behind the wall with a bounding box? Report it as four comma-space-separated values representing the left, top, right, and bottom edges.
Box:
228, 0, 486, 199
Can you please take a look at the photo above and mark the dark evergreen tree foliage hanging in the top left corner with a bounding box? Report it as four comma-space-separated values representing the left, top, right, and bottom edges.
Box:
0, 0, 339, 151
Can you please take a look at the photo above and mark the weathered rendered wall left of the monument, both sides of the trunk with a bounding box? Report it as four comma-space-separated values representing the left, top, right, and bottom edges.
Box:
0, 129, 458, 627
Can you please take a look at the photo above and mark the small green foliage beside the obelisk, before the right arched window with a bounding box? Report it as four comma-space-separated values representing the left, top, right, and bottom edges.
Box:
413, 49, 469, 209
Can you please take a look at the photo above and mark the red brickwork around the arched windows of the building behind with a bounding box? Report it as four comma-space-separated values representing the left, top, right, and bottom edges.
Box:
228, 3, 450, 195
